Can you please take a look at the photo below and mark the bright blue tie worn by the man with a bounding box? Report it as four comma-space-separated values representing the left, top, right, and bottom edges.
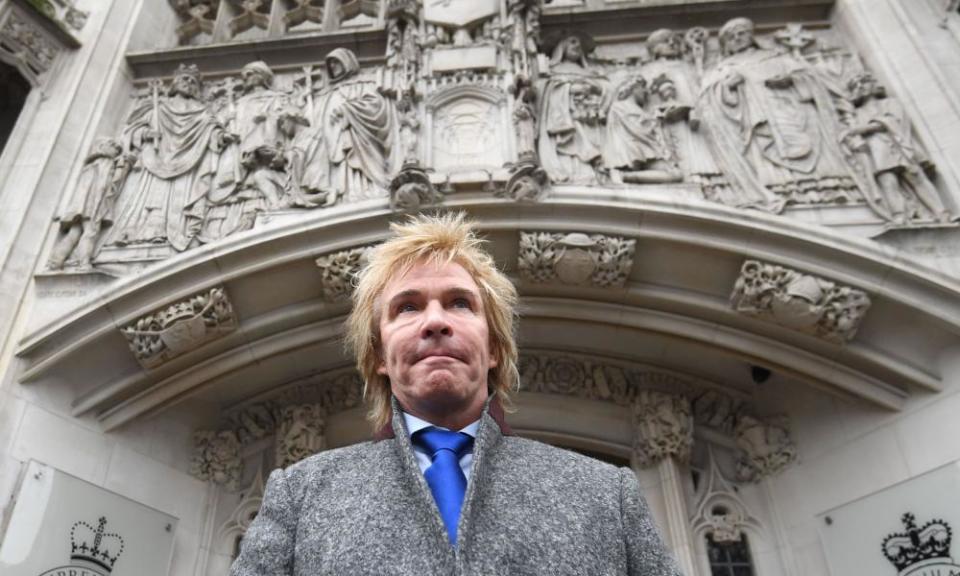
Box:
413, 427, 473, 546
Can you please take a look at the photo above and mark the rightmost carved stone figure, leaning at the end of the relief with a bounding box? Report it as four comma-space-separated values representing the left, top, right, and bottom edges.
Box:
841, 72, 951, 225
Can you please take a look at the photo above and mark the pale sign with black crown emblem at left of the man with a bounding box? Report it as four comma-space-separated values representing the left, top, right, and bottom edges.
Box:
0, 461, 178, 576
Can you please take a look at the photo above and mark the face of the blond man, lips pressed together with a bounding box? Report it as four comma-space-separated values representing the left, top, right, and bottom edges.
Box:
377, 262, 497, 423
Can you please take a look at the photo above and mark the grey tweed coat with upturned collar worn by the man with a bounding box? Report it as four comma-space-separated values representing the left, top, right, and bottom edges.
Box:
230, 402, 680, 576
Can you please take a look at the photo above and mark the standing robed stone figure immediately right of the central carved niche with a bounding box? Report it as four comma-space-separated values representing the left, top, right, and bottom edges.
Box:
537, 36, 610, 183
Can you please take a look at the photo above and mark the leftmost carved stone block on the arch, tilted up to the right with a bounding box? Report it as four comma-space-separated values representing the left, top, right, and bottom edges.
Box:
120, 288, 237, 368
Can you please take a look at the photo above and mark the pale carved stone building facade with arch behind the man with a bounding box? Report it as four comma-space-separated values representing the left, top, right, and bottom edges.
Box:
0, 0, 960, 576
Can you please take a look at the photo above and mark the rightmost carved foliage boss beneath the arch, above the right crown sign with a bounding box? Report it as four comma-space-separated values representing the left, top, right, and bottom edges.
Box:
734, 416, 797, 482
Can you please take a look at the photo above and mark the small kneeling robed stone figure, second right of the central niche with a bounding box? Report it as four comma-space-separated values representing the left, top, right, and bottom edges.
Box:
603, 75, 683, 183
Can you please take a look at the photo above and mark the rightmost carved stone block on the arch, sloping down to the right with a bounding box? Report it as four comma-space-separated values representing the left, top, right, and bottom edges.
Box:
730, 260, 870, 344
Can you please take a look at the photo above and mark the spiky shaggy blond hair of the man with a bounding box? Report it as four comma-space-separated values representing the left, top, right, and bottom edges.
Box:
345, 212, 520, 430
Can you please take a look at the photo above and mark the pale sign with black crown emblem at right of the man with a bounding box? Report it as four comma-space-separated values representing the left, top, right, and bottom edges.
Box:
820, 462, 960, 576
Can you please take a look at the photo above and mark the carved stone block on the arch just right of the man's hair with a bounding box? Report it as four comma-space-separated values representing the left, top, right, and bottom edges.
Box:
517, 232, 637, 288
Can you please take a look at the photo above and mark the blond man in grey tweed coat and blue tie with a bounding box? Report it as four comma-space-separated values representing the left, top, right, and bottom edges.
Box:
232, 215, 679, 576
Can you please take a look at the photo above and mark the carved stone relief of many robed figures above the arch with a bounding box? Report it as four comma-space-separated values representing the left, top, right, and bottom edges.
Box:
48, 0, 956, 273
